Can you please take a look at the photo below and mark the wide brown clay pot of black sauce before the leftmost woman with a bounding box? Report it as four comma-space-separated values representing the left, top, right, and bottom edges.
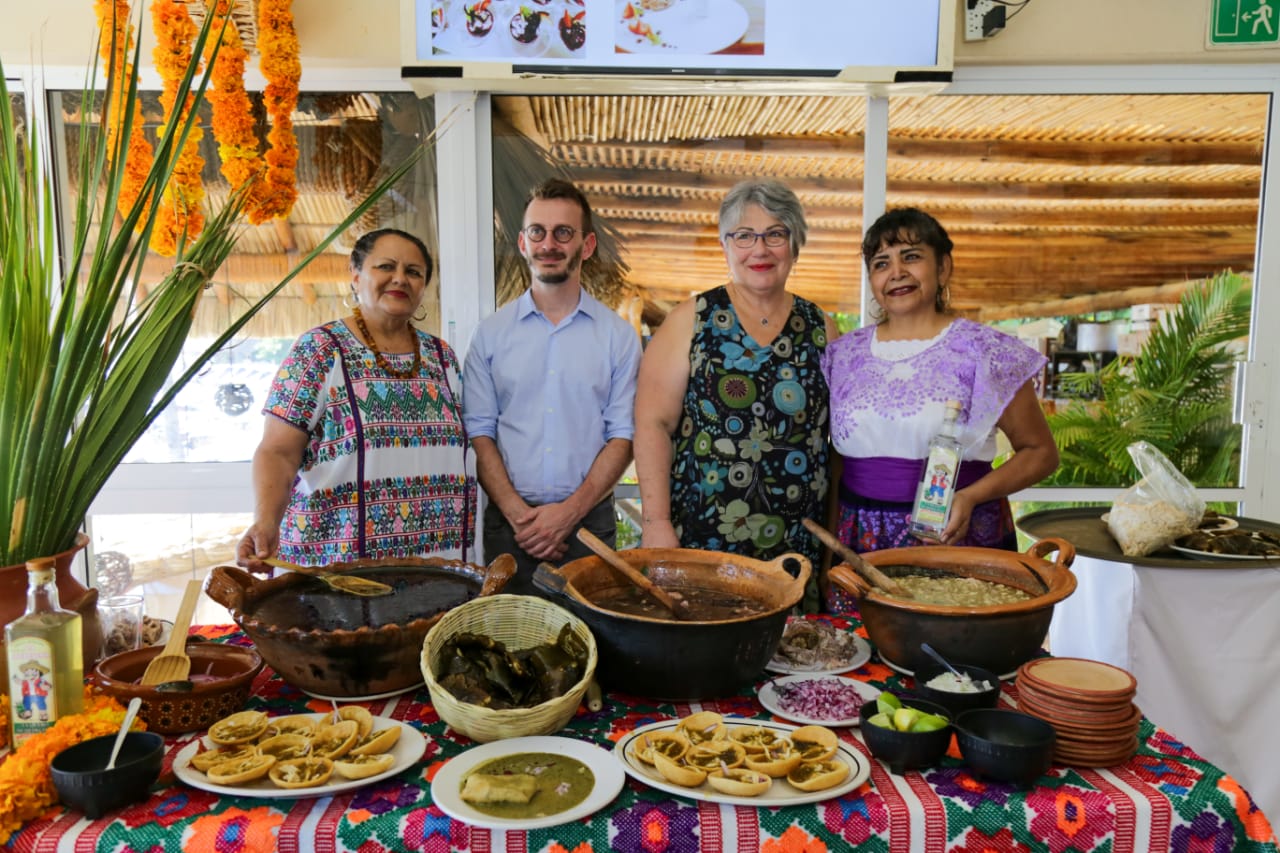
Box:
206, 555, 516, 699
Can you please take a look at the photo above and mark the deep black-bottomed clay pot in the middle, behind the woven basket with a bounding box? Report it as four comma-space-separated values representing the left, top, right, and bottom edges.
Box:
534, 548, 812, 702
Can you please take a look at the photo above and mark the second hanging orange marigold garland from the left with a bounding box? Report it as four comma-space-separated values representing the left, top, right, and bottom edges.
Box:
151, 0, 205, 256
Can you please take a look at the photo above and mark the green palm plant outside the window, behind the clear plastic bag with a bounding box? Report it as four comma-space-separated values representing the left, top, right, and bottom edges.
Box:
1046, 272, 1251, 485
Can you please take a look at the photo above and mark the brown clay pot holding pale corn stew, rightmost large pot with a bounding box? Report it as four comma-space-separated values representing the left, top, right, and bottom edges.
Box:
829, 538, 1075, 675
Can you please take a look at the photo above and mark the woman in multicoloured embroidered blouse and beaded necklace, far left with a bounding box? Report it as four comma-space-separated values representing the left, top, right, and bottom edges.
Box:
237, 228, 476, 570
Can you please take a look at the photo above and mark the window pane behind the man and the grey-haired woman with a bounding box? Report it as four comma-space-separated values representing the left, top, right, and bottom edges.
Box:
493, 96, 867, 325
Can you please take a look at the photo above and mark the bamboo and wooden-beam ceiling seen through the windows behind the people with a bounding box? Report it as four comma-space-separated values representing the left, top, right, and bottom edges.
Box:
497, 95, 1267, 319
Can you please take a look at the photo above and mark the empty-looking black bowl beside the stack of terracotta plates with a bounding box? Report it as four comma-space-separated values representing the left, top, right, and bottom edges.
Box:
955, 708, 1057, 788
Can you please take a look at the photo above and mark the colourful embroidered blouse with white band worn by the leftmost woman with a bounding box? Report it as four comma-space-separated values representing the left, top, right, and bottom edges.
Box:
262, 321, 476, 566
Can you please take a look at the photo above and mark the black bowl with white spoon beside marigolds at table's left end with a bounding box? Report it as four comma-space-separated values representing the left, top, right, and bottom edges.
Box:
50, 731, 164, 818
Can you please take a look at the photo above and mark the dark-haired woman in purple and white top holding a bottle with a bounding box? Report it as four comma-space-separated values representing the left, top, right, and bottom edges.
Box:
822, 207, 1057, 611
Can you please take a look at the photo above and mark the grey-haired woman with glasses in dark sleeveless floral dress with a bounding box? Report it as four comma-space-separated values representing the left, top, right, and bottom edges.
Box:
635, 181, 835, 605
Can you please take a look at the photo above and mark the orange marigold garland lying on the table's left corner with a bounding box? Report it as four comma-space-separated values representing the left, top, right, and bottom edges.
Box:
0, 688, 136, 844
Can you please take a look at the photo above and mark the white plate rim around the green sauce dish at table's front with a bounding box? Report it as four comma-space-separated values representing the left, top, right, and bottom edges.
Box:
431, 735, 626, 829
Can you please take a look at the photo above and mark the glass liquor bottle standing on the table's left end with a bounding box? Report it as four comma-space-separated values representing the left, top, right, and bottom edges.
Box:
4, 557, 84, 749
